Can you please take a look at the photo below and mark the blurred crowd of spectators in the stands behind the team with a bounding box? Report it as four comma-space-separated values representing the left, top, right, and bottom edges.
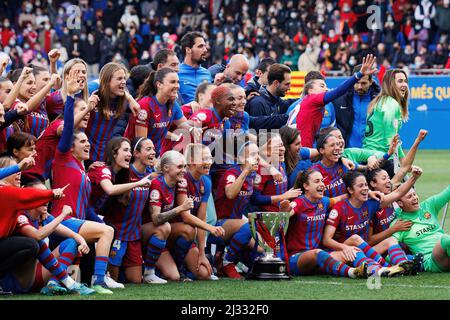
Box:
0, 0, 450, 77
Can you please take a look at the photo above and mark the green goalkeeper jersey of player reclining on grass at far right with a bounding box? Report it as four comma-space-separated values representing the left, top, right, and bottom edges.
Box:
391, 185, 450, 255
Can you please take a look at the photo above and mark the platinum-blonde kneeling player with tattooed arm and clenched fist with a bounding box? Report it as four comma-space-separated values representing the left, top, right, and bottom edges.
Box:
142, 150, 194, 284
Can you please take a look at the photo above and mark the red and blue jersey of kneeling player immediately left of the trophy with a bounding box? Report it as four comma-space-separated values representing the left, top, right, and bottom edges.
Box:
214, 166, 256, 220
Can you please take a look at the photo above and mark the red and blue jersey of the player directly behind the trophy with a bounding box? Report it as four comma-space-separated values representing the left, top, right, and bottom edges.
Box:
255, 163, 288, 212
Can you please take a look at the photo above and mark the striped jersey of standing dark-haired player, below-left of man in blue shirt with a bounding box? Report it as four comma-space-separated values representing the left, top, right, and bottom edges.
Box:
124, 96, 183, 157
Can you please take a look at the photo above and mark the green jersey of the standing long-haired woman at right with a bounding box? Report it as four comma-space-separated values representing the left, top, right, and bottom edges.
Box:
363, 97, 405, 158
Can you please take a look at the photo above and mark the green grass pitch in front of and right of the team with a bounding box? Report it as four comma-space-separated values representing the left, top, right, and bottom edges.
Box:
4, 151, 450, 300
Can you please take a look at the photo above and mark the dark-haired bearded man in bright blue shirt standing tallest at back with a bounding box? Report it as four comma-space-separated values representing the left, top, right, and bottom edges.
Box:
178, 32, 212, 104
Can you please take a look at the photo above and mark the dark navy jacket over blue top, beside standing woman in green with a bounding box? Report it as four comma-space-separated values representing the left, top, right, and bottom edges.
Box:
333, 81, 381, 144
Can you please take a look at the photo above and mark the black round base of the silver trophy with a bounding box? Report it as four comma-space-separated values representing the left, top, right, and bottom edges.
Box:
247, 258, 291, 280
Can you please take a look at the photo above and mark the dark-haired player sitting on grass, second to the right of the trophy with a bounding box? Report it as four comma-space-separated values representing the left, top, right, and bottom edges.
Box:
323, 169, 422, 277
